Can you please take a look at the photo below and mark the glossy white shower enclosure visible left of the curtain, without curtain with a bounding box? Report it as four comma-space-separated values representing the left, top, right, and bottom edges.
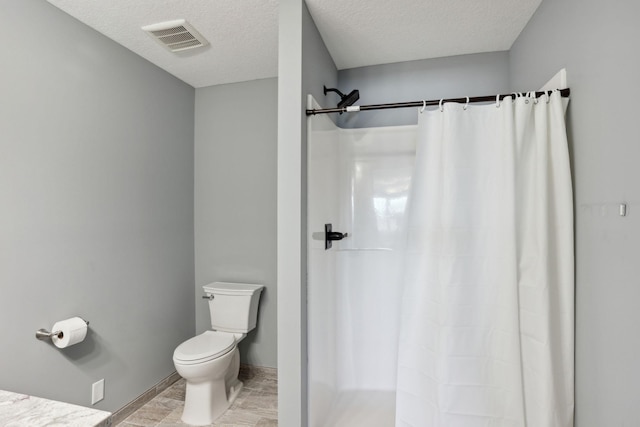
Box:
307, 95, 416, 427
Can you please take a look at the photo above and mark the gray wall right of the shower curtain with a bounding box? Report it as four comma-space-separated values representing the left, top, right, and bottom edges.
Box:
510, 0, 640, 427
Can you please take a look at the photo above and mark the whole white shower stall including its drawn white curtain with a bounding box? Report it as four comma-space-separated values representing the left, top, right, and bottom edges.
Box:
307, 84, 574, 427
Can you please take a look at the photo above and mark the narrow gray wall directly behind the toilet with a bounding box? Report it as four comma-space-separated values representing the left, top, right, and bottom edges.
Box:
195, 78, 278, 367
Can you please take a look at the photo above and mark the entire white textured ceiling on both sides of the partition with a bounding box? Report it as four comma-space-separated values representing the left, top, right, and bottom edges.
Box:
48, 0, 541, 87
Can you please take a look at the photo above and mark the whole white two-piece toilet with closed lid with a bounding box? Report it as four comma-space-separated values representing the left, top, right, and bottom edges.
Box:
173, 282, 264, 425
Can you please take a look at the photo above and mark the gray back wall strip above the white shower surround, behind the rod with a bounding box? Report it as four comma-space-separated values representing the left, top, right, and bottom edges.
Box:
338, 52, 509, 128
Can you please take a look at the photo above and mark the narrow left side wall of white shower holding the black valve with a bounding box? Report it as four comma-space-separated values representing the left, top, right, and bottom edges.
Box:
307, 104, 339, 427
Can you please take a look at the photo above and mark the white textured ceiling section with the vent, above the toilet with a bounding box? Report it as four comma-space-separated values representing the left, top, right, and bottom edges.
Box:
48, 0, 278, 87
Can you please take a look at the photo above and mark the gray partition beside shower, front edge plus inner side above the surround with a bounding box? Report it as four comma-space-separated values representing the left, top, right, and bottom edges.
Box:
278, 0, 338, 427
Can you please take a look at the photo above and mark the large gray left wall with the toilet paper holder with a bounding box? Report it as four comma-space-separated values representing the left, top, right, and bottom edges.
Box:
0, 0, 194, 411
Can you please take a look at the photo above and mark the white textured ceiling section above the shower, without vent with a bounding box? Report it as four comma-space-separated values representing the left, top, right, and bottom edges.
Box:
306, 0, 541, 69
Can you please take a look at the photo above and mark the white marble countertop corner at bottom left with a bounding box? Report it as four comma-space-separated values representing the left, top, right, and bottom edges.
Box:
0, 390, 111, 427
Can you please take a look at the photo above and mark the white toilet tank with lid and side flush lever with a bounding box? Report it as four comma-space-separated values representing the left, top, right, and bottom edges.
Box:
202, 282, 264, 333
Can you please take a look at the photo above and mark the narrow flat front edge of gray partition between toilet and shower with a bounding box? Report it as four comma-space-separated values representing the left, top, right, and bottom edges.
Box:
277, 0, 306, 427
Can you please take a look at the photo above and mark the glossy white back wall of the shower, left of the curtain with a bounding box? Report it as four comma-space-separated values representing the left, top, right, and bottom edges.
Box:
333, 126, 416, 390
